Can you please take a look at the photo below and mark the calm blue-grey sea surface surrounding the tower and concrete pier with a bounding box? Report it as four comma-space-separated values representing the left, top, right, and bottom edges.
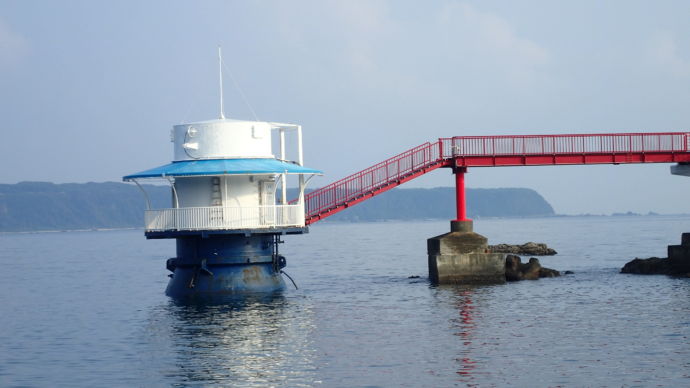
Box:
0, 217, 690, 387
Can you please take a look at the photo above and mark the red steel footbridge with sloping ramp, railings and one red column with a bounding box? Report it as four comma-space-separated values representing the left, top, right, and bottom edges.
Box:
305, 132, 690, 224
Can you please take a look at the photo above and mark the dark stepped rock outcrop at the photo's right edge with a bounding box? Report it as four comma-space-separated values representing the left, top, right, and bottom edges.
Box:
621, 233, 690, 277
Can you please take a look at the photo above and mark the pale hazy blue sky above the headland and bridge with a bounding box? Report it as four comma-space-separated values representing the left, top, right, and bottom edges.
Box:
0, 0, 690, 216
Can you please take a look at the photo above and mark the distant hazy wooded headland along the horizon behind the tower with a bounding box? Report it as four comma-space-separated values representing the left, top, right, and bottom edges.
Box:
0, 182, 556, 232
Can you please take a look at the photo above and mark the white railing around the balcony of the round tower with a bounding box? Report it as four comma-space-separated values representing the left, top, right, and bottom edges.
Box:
144, 204, 304, 232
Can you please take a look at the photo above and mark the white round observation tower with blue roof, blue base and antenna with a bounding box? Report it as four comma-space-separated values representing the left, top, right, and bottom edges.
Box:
123, 50, 321, 298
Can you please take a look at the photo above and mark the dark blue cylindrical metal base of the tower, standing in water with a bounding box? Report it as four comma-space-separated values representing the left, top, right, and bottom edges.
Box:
165, 234, 285, 299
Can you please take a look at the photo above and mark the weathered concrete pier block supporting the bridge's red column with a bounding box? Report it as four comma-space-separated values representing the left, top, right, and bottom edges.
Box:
427, 220, 506, 284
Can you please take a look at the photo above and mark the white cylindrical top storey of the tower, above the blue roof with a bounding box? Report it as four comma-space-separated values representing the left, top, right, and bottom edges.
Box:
171, 119, 274, 161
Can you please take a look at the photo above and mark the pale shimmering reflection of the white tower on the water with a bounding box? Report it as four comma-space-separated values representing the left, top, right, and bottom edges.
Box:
147, 295, 315, 386
